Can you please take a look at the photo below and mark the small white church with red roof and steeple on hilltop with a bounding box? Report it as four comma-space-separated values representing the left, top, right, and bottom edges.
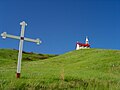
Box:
76, 37, 90, 50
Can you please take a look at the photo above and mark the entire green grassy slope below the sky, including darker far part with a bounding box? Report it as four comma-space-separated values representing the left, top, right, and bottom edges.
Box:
0, 49, 120, 90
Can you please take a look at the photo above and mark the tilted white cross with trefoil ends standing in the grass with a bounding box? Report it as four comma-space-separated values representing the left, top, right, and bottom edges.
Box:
1, 21, 41, 78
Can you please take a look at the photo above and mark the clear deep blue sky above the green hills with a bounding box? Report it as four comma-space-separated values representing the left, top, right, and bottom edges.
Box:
0, 0, 120, 54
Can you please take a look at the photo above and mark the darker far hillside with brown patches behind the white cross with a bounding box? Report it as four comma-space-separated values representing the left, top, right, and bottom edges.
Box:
0, 49, 58, 65
